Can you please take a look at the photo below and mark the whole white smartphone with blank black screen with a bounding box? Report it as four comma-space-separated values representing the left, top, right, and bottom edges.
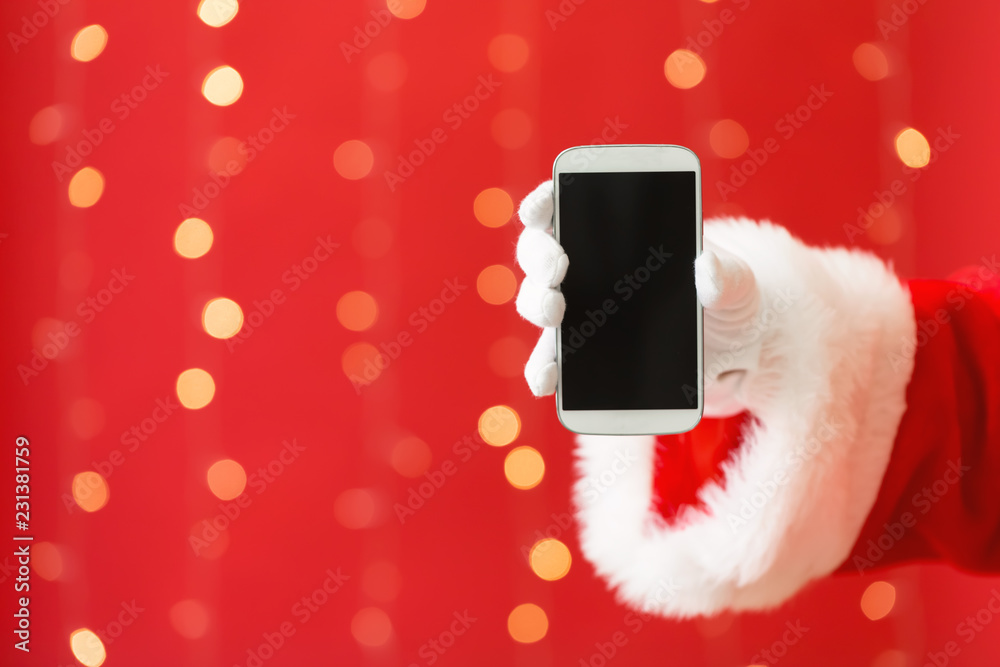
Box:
553, 145, 704, 435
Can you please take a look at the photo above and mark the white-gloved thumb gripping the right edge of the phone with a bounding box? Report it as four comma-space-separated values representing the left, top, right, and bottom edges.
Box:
694, 248, 759, 317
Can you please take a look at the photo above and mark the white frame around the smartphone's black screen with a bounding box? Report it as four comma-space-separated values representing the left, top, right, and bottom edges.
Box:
552, 144, 705, 435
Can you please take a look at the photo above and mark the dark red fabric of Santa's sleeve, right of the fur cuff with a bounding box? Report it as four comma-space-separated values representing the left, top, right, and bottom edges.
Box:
838, 271, 1000, 572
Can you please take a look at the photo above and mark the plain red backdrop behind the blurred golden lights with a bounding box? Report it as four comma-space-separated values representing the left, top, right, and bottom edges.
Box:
0, 0, 1000, 667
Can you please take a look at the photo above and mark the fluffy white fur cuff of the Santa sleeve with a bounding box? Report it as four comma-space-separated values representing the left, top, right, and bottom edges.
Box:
574, 219, 916, 618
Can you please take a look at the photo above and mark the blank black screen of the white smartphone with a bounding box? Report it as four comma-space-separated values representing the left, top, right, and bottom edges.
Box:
559, 171, 699, 410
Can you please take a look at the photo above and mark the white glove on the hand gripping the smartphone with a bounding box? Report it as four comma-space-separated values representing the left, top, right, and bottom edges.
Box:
516, 181, 767, 417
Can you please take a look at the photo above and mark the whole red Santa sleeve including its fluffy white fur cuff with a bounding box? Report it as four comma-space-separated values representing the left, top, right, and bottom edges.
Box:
574, 220, 1000, 618
